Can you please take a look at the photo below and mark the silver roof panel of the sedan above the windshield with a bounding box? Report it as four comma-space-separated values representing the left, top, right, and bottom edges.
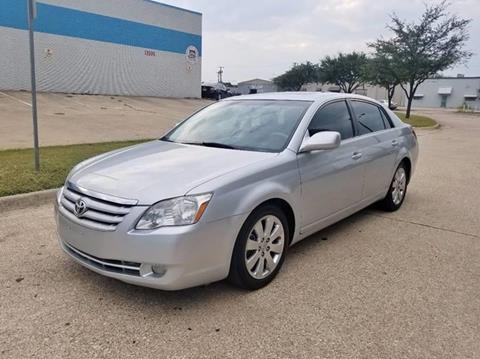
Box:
224, 91, 377, 102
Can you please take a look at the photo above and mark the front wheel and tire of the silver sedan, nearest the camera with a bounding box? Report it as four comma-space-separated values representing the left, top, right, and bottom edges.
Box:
228, 205, 289, 290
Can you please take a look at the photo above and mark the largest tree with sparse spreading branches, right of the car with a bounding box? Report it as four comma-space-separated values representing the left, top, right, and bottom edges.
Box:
369, 0, 472, 118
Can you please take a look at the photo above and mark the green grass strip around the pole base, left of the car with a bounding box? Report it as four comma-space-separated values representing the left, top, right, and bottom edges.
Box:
0, 141, 150, 197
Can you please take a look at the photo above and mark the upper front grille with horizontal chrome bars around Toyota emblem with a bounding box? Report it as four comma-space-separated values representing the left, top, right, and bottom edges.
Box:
60, 186, 135, 231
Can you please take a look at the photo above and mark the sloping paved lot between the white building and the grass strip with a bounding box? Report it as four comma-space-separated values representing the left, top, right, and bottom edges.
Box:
0, 91, 211, 150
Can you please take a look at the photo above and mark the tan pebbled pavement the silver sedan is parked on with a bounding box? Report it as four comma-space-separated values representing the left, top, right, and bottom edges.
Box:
0, 112, 480, 359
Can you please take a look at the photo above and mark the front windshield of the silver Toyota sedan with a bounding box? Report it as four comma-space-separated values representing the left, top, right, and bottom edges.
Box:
162, 100, 312, 152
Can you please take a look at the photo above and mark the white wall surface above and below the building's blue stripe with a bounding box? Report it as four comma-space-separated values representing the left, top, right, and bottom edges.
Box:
0, 0, 201, 97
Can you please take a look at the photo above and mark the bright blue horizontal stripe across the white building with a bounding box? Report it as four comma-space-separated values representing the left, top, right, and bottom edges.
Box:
0, 0, 202, 54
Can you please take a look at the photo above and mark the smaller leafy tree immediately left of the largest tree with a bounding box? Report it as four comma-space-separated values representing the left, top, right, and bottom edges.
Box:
364, 54, 400, 108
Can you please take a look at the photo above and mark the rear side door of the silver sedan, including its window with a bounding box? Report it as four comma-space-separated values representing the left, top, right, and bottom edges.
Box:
349, 99, 400, 200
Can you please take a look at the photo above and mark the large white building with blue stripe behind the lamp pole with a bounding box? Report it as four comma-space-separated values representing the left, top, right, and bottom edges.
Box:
0, 0, 202, 97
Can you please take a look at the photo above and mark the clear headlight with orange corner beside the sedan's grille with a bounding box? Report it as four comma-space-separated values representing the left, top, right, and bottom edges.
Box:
136, 193, 212, 229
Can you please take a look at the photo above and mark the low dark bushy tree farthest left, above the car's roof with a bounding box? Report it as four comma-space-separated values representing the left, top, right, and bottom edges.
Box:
273, 61, 319, 91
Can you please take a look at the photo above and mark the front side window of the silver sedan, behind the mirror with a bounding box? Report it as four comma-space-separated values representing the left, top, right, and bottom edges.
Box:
308, 101, 353, 140
